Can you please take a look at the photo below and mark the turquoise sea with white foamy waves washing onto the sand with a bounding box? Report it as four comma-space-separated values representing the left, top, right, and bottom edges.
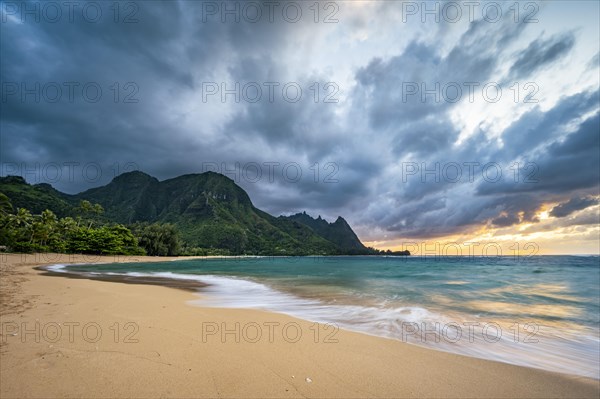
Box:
49, 256, 600, 379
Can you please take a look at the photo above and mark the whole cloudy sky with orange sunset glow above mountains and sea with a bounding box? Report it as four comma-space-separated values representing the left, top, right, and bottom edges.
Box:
0, 0, 600, 256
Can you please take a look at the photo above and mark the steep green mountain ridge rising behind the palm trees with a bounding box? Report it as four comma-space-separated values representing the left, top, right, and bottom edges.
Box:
0, 171, 371, 255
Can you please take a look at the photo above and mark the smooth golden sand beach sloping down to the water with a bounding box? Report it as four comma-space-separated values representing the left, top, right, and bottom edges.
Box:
0, 254, 600, 398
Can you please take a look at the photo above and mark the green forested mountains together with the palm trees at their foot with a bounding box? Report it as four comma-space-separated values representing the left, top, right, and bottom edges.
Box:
0, 171, 410, 256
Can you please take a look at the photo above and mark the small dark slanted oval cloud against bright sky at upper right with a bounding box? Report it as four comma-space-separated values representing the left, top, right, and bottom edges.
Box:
509, 33, 575, 77
